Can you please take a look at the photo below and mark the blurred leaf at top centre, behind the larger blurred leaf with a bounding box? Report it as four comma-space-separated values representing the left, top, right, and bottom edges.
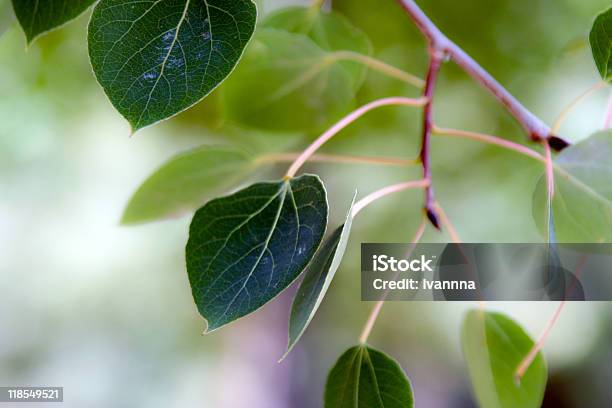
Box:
263, 7, 372, 91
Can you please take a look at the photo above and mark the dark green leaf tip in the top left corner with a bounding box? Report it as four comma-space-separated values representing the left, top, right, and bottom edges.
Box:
13, 0, 95, 44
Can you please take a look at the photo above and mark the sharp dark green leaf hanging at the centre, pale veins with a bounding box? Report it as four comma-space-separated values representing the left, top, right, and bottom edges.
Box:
186, 175, 328, 331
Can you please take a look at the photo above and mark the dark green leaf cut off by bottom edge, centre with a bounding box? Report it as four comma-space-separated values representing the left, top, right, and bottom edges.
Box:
325, 345, 414, 408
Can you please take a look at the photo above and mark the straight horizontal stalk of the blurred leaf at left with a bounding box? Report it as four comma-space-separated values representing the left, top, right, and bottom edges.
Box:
255, 153, 419, 166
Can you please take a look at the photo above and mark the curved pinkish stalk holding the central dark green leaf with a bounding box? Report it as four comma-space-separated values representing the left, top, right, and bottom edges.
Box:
286, 96, 426, 177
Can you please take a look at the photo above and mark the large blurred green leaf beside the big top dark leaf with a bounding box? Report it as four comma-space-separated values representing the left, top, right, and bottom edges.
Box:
225, 28, 355, 131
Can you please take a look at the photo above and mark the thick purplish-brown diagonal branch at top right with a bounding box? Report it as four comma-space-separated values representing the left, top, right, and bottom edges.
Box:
397, 0, 567, 148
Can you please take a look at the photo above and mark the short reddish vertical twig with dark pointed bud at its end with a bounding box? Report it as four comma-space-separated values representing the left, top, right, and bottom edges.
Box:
420, 50, 443, 229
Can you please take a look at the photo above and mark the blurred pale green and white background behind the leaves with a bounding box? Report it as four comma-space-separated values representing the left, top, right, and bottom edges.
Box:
0, 0, 612, 408
